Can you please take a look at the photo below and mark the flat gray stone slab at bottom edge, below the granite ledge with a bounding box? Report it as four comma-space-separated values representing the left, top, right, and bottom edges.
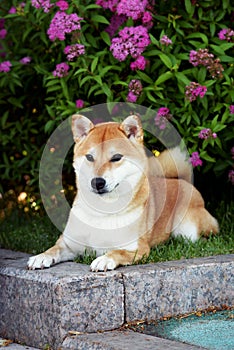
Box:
61, 331, 203, 350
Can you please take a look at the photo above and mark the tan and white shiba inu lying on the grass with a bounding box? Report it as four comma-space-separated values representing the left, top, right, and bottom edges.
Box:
28, 115, 218, 271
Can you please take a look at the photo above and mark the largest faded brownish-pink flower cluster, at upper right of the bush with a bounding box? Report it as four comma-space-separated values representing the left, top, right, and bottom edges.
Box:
189, 49, 224, 78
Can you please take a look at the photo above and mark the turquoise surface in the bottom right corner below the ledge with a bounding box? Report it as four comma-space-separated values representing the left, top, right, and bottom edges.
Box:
137, 310, 234, 350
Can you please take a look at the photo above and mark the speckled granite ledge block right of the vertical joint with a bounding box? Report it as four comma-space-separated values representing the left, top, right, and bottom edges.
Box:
123, 255, 234, 322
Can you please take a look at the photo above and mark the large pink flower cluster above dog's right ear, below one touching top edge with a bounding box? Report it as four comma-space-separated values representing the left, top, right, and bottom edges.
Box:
110, 26, 150, 61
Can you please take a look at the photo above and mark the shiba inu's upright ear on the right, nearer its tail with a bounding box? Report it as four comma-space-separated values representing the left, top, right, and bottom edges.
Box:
120, 115, 144, 143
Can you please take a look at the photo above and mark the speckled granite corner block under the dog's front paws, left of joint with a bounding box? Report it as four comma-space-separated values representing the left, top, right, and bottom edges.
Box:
0, 252, 124, 349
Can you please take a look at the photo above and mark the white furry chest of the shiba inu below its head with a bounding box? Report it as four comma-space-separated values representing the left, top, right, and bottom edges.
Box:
63, 205, 142, 255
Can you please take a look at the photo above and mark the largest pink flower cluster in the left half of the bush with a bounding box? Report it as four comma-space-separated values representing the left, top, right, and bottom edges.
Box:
47, 11, 82, 41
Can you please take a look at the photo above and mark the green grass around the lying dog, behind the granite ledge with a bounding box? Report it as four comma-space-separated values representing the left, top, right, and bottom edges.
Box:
0, 202, 234, 264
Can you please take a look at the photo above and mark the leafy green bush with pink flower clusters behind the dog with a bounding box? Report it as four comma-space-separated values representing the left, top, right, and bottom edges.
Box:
0, 0, 234, 200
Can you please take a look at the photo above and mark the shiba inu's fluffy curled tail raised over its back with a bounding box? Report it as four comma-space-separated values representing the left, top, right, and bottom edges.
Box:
153, 146, 193, 183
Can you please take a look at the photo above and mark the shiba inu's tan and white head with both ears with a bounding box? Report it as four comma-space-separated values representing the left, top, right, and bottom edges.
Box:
72, 115, 147, 195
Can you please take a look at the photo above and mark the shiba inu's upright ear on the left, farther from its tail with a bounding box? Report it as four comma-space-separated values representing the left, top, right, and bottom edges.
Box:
72, 114, 94, 142
